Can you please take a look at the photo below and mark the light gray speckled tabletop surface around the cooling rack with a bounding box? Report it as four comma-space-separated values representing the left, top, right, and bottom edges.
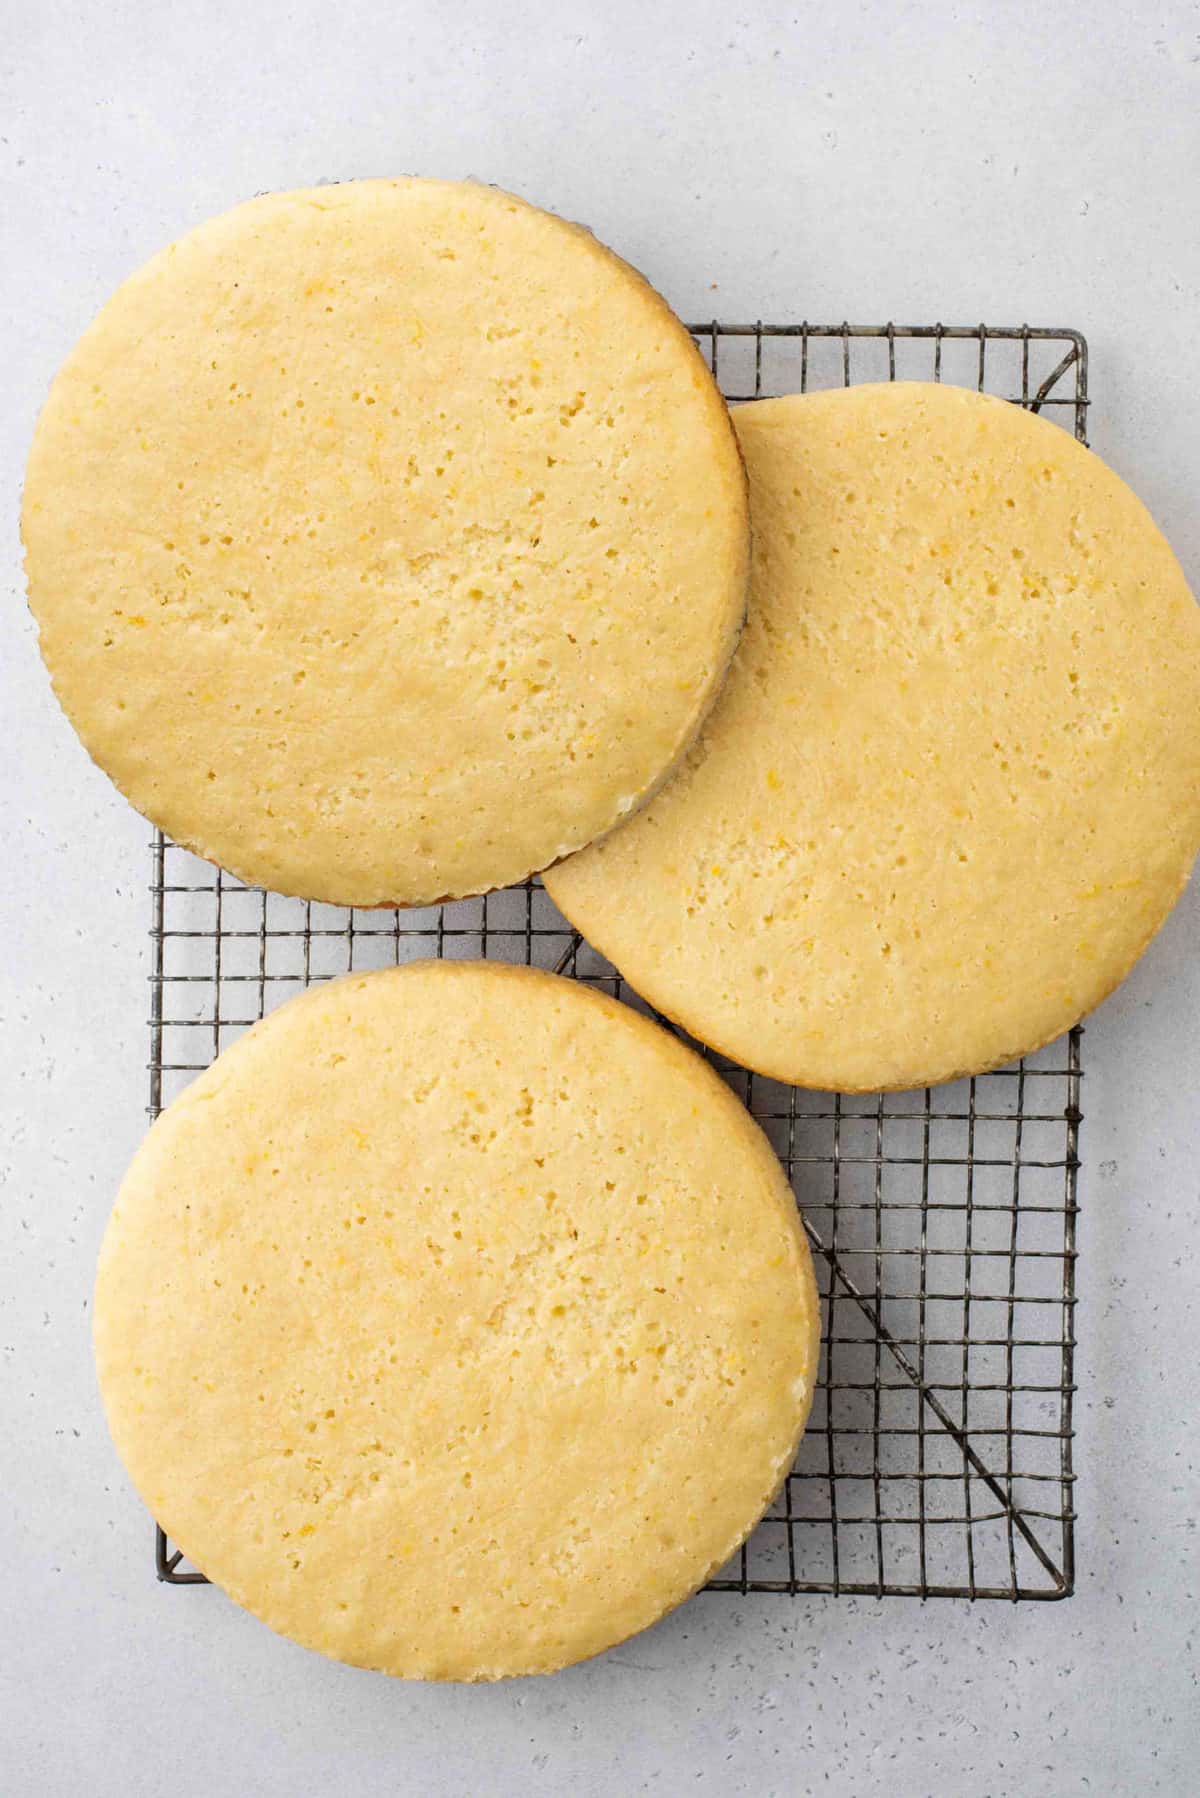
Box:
0, 0, 1200, 1798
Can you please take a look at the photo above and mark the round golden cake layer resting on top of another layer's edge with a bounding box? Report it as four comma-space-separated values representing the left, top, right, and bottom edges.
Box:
22, 180, 748, 906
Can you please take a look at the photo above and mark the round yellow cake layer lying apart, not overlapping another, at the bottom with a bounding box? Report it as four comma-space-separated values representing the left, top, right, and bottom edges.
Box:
95, 962, 819, 1679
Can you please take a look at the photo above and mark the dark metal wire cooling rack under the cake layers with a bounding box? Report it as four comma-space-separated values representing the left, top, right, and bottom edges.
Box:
149, 324, 1088, 1600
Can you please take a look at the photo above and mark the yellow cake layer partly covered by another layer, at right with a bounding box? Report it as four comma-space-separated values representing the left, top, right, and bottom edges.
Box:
547, 383, 1200, 1091
